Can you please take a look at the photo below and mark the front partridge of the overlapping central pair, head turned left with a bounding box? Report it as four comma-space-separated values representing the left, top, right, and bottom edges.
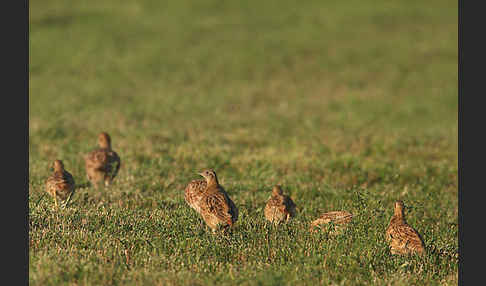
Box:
199, 170, 238, 231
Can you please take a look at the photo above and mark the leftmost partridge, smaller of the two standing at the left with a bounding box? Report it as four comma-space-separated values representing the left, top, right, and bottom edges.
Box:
46, 160, 75, 207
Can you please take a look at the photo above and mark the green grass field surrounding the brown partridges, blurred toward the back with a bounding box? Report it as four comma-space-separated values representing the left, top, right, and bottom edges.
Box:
29, 0, 458, 285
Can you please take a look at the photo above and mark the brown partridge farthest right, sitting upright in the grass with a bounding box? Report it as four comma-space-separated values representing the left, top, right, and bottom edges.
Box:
385, 201, 425, 254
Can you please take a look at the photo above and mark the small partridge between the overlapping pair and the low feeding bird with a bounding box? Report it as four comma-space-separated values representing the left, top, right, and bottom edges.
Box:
264, 185, 296, 224
